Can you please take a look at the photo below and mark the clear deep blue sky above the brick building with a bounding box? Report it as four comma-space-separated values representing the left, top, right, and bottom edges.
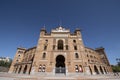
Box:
0, 0, 120, 64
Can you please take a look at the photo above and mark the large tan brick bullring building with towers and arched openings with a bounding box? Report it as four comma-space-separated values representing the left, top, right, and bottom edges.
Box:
9, 26, 112, 75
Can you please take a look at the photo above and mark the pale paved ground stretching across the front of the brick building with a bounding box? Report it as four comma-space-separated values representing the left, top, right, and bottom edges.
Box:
0, 73, 120, 80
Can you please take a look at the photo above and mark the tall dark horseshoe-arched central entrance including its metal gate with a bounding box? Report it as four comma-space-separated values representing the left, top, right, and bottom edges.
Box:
55, 55, 66, 73
